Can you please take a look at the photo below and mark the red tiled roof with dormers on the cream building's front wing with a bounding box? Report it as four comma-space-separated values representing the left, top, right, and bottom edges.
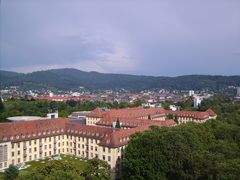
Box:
0, 118, 176, 147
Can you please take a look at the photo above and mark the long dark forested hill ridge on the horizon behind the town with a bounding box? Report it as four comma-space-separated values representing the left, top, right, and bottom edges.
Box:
0, 68, 240, 91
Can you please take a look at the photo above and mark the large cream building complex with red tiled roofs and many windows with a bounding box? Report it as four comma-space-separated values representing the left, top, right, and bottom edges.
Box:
0, 108, 216, 177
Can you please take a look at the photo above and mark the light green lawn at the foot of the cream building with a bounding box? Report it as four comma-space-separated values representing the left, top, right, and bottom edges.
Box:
0, 155, 88, 180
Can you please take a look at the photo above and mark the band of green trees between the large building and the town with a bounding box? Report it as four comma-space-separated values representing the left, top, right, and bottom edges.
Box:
0, 99, 142, 122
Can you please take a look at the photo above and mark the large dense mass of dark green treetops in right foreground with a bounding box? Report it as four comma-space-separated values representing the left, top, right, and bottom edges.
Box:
123, 121, 240, 179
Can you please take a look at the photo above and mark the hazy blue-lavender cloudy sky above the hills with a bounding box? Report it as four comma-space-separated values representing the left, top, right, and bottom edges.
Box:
0, 0, 240, 76
